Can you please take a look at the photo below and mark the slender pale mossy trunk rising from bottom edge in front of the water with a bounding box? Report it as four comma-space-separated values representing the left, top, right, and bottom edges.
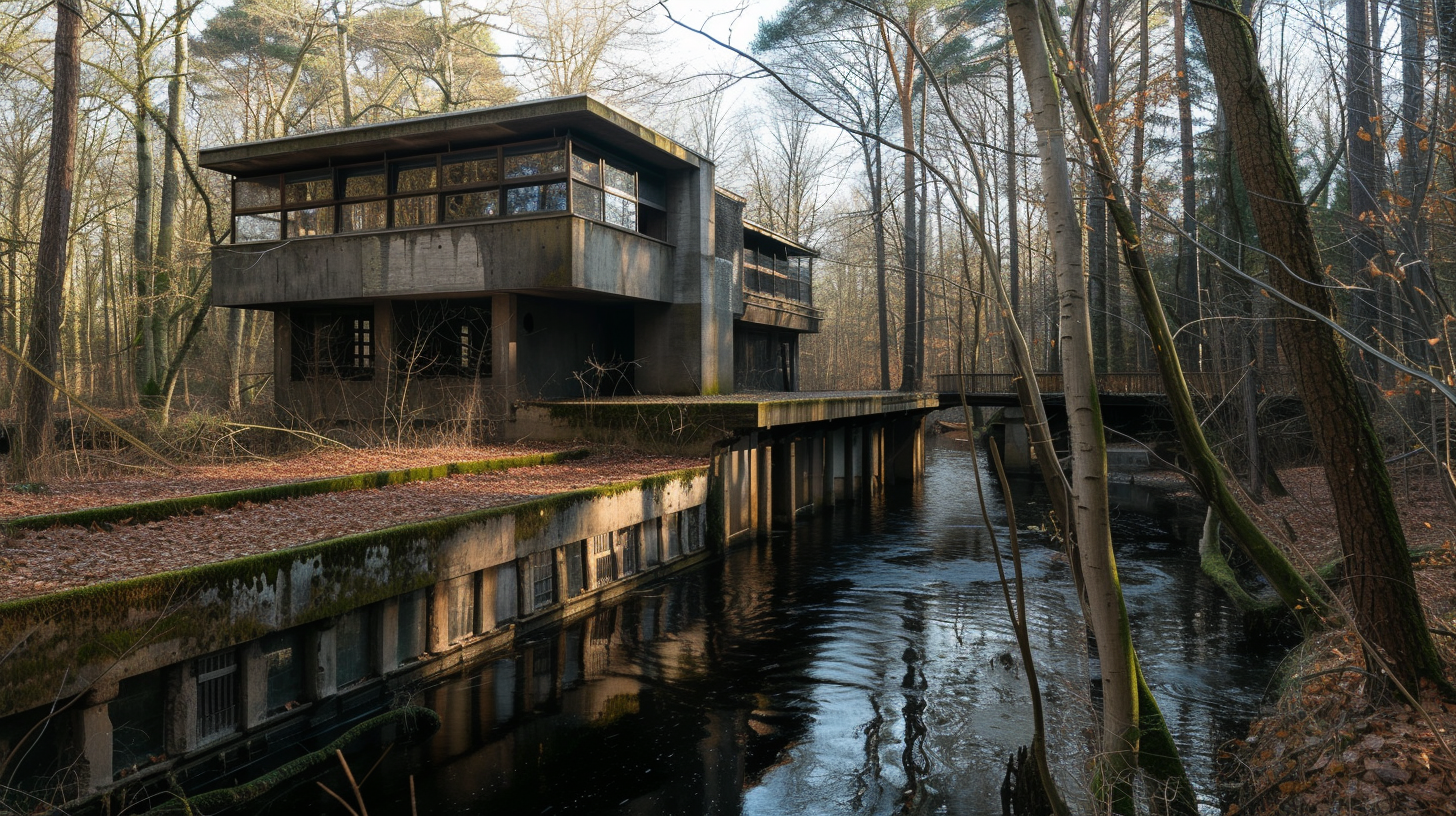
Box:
1006, 0, 1139, 813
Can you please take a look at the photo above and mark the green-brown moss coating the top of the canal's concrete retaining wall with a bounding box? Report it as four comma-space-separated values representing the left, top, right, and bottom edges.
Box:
0, 468, 705, 713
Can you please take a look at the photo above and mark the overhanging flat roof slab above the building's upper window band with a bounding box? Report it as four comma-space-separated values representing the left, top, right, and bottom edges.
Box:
198, 95, 708, 176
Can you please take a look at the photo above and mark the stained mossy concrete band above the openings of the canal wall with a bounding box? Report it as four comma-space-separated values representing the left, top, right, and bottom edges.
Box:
0, 468, 708, 717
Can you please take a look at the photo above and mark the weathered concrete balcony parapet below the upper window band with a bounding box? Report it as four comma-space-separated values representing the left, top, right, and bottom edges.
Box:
213, 214, 675, 307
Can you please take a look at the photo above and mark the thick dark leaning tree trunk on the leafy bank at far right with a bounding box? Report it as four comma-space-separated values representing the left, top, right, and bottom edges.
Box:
1194, 0, 1450, 694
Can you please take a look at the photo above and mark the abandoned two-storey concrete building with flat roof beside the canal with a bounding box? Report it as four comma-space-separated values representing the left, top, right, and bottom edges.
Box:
199, 96, 823, 421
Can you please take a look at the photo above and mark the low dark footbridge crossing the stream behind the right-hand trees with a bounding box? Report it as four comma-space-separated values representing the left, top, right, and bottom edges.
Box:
932, 367, 1297, 408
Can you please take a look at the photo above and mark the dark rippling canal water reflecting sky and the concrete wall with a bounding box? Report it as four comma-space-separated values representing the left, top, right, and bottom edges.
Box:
259, 450, 1283, 816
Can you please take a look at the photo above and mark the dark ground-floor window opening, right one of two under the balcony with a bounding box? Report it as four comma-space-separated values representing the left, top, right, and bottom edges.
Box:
395, 299, 491, 377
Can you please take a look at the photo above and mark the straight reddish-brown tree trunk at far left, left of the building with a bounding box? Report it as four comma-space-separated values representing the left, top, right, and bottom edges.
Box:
15, 0, 83, 479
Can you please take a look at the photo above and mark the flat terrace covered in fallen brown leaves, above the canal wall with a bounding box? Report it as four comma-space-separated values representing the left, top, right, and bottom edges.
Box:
0, 444, 706, 602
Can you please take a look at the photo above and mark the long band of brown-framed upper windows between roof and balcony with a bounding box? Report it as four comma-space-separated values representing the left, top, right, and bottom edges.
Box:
233, 138, 667, 243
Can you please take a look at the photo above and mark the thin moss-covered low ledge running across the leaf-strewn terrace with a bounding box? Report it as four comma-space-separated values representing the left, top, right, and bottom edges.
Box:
3, 447, 590, 533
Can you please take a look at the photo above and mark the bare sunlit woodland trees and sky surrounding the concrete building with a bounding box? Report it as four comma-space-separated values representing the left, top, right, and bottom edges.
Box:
0, 0, 1456, 813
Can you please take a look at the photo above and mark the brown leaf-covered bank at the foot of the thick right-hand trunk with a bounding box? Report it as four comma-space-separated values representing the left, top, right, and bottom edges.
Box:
1188, 468, 1456, 815
